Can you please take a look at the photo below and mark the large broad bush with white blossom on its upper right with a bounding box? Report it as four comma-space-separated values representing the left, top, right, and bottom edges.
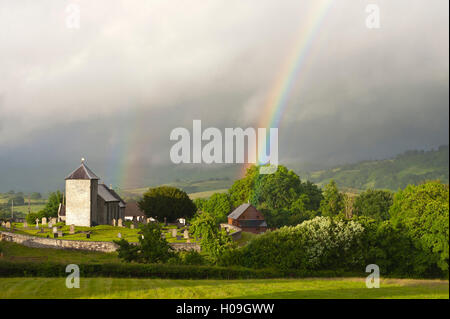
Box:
222, 217, 364, 270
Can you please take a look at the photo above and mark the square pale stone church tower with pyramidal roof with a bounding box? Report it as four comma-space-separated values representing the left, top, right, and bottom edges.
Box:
66, 159, 99, 227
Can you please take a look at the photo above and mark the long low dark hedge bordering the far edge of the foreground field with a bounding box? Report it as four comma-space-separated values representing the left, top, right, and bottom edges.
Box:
0, 261, 367, 279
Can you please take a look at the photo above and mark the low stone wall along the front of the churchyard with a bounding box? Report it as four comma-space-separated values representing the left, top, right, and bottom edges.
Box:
0, 231, 200, 253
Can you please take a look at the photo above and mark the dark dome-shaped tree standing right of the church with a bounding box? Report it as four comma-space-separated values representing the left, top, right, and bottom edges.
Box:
138, 186, 196, 221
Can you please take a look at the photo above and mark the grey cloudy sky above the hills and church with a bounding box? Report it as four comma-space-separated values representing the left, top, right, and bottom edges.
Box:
0, 0, 449, 191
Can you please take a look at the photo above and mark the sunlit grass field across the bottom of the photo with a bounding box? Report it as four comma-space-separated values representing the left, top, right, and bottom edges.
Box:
0, 278, 449, 299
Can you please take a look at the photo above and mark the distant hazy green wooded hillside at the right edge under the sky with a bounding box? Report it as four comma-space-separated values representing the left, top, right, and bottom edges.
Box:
301, 145, 449, 190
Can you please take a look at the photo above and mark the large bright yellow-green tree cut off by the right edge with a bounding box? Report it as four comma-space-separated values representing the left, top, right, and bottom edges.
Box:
389, 181, 449, 275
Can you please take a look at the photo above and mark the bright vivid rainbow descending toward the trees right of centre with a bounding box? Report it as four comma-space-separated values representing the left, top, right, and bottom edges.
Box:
240, 0, 334, 177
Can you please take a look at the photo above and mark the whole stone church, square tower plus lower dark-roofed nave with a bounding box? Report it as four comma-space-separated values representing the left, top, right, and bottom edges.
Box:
64, 159, 126, 227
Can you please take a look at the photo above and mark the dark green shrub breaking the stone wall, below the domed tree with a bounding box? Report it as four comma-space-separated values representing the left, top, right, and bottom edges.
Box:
115, 223, 174, 263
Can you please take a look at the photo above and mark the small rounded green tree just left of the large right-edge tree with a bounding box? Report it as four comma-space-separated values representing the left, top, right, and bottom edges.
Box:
353, 189, 394, 221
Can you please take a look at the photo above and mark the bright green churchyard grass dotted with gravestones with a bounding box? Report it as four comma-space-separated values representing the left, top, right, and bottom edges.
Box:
6, 223, 194, 243
